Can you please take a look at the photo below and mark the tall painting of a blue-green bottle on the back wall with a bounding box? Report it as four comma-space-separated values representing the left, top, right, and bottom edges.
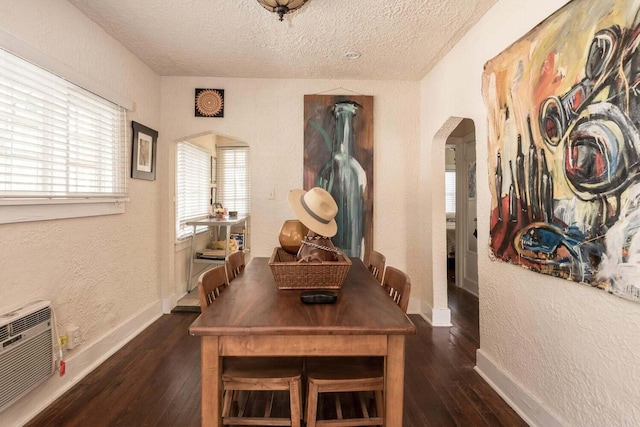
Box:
304, 95, 373, 259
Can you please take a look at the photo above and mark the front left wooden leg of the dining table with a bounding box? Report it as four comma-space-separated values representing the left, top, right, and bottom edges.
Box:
200, 336, 222, 427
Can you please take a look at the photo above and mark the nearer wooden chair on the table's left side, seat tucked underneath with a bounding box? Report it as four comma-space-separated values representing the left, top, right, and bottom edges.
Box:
198, 257, 303, 427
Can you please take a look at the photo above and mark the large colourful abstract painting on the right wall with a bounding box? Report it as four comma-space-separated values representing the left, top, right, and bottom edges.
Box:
483, 0, 640, 301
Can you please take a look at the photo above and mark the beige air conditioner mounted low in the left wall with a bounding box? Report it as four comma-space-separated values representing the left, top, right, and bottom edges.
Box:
0, 301, 55, 412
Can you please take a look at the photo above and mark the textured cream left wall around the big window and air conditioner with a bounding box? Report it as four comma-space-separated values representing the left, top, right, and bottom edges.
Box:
0, 0, 166, 426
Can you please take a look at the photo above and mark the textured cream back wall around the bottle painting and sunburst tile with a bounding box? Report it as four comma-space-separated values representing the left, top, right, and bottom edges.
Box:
161, 77, 423, 306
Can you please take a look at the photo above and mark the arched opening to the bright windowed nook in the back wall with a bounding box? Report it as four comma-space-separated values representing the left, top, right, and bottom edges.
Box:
169, 131, 251, 312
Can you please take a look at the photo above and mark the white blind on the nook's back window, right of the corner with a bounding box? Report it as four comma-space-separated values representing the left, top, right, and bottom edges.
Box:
216, 147, 251, 215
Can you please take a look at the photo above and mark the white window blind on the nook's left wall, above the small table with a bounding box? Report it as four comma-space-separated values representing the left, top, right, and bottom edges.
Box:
176, 142, 211, 239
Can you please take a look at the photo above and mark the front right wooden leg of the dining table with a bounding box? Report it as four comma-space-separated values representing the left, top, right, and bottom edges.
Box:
384, 335, 404, 427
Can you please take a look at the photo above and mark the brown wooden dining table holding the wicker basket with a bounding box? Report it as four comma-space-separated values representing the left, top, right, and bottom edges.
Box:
189, 257, 415, 427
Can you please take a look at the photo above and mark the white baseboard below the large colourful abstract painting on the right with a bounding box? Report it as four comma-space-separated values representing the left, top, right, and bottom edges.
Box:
474, 349, 563, 427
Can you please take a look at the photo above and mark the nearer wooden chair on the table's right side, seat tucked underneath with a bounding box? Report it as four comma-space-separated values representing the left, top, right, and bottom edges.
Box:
305, 267, 411, 427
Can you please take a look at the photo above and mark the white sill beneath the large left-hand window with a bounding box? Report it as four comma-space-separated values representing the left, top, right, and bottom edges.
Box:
0, 198, 129, 224
